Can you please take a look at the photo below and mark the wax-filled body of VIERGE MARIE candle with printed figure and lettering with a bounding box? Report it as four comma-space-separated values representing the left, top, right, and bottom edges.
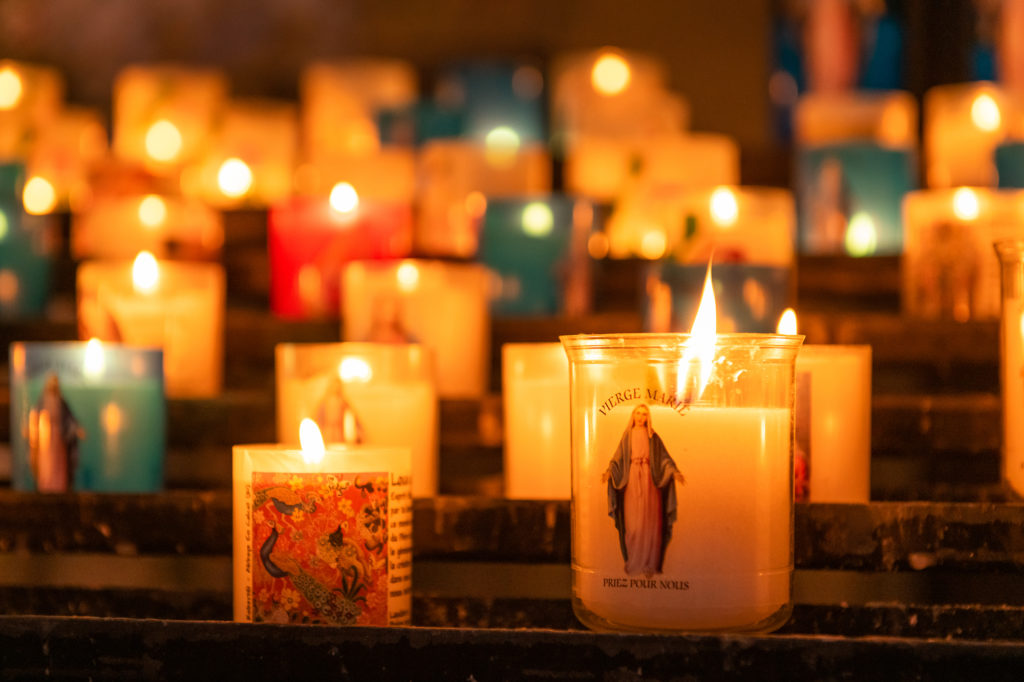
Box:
573, 386, 793, 628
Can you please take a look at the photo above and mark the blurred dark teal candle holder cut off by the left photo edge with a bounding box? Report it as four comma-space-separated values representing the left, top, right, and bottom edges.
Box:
0, 164, 54, 318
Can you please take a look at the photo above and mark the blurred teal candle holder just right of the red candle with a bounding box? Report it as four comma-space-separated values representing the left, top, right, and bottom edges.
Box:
479, 196, 595, 315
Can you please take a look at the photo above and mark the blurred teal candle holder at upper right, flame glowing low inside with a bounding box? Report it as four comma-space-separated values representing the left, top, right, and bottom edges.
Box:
797, 141, 918, 256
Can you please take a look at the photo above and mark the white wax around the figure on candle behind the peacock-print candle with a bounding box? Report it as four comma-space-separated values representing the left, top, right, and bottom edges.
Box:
278, 372, 438, 498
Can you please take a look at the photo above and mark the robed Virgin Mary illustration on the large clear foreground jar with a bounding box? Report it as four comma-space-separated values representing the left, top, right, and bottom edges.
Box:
601, 403, 686, 578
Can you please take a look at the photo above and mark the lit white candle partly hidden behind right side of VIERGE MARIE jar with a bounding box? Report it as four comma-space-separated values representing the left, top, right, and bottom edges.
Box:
778, 309, 871, 503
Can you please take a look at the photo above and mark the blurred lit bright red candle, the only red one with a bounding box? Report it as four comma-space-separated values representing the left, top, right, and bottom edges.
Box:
267, 187, 413, 318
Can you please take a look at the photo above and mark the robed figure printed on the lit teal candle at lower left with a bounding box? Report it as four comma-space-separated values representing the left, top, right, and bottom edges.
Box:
27, 373, 85, 493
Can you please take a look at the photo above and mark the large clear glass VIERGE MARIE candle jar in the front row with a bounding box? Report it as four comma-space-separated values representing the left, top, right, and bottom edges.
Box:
562, 334, 802, 632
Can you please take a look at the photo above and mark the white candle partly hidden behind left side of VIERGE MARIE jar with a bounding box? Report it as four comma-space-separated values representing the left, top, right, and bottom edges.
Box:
502, 343, 570, 500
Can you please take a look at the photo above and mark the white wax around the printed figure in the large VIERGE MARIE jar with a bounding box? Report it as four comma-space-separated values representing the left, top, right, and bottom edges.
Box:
572, 400, 793, 630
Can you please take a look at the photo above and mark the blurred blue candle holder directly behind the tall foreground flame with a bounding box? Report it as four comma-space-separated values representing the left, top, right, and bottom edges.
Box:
644, 260, 795, 334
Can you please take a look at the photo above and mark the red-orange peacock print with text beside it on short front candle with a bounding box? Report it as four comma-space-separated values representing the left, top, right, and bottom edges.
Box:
246, 472, 412, 625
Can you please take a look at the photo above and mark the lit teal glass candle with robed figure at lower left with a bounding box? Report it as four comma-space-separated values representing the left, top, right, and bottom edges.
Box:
10, 341, 166, 493
